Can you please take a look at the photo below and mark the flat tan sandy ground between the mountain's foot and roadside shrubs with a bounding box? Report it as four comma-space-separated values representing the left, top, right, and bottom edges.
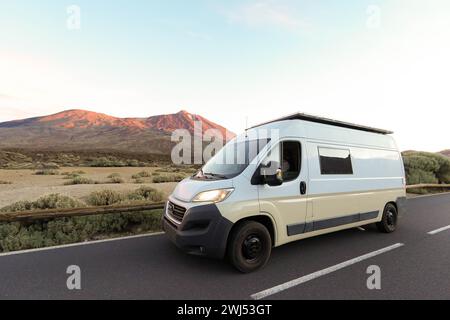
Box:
0, 167, 176, 208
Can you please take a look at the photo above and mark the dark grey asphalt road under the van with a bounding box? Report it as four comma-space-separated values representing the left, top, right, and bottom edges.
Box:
0, 194, 450, 299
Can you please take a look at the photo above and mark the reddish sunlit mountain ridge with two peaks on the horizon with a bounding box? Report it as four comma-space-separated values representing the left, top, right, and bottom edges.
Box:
0, 109, 234, 154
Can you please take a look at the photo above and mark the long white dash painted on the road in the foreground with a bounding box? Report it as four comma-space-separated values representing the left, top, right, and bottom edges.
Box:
250, 243, 404, 300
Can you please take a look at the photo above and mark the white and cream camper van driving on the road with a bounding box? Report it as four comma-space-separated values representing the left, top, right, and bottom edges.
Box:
163, 113, 406, 272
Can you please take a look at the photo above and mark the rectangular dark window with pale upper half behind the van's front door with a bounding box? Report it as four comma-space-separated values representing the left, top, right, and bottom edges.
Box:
319, 147, 353, 175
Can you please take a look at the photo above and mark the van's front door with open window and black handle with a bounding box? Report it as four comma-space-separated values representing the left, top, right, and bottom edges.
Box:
258, 139, 308, 241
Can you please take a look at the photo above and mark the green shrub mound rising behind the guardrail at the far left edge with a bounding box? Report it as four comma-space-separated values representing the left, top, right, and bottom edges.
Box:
0, 193, 84, 212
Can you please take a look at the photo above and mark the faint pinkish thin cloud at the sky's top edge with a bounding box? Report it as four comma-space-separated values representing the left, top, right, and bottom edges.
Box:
221, 1, 306, 31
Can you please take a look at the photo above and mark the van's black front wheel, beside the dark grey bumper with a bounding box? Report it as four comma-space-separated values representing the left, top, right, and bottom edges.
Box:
228, 221, 272, 273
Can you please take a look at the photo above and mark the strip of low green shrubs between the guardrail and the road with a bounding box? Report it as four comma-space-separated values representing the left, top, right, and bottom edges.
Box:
0, 210, 162, 252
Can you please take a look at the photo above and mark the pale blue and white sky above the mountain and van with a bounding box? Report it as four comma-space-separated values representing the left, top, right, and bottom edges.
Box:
0, 0, 450, 151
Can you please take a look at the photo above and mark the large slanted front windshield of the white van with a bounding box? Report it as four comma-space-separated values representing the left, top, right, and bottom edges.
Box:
194, 139, 270, 179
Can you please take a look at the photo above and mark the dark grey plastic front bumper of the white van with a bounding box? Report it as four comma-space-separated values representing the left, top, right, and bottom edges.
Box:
162, 204, 233, 259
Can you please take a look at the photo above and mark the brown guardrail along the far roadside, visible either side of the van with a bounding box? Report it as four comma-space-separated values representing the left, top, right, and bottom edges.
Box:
0, 184, 450, 223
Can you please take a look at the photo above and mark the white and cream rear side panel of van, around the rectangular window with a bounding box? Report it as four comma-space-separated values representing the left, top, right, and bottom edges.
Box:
298, 140, 405, 244
